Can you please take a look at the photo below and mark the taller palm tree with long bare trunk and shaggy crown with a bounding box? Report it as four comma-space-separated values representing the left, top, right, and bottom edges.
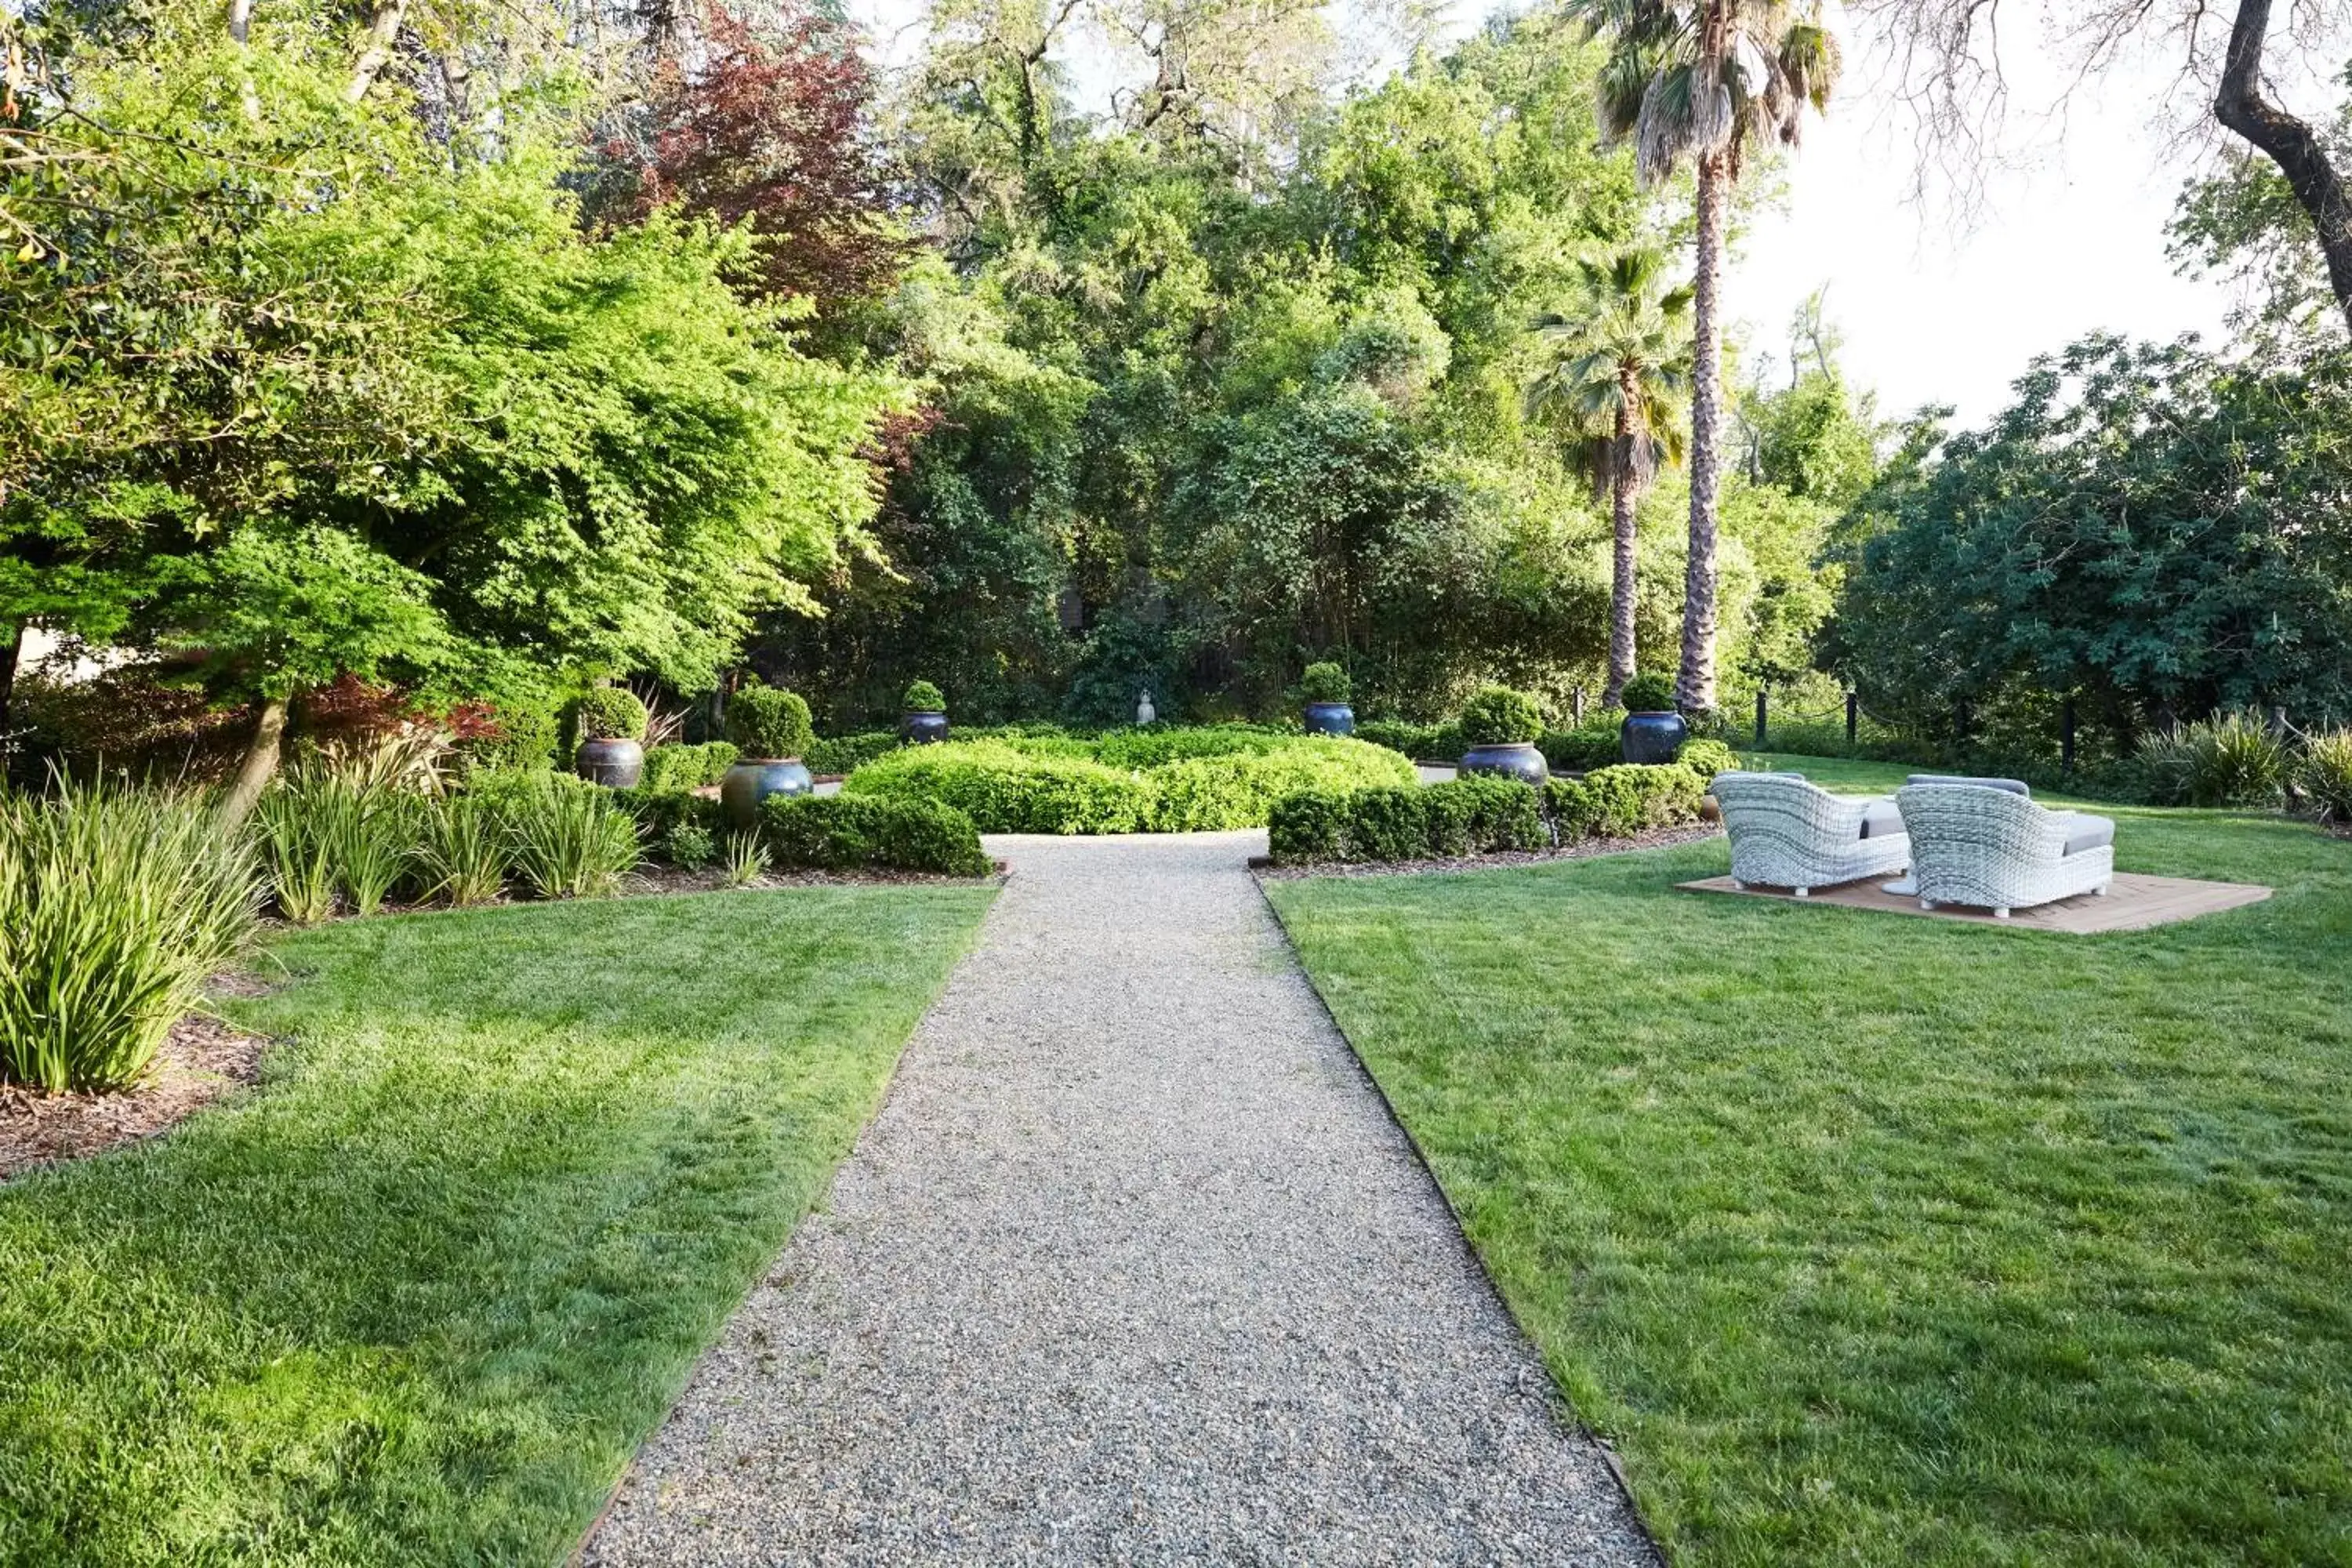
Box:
1571, 0, 1842, 713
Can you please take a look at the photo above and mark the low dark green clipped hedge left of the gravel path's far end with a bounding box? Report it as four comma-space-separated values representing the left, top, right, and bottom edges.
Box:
614, 785, 995, 877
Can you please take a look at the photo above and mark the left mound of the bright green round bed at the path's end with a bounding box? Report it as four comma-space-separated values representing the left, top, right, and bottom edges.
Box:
842, 741, 1157, 834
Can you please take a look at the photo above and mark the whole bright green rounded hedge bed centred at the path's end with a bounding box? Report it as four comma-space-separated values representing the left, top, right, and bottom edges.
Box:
842, 724, 1418, 834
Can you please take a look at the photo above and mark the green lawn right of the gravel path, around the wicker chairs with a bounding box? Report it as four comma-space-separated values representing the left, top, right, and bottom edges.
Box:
1268, 780, 2352, 1566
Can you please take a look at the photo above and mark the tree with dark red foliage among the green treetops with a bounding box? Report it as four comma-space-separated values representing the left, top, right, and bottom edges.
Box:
607, 0, 910, 308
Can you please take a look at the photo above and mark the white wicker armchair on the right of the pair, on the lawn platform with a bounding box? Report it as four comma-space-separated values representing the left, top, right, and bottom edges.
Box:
1896, 783, 2114, 919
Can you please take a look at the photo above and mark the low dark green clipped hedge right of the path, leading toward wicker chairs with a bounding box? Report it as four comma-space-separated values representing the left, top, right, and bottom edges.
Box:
1265, 762, 1705, 865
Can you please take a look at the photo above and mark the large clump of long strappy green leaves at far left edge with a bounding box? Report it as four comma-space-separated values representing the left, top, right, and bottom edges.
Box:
0, 783, 261, 1093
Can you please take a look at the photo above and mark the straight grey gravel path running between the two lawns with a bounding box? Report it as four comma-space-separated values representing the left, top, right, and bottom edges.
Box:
588, 832, 1656, 1566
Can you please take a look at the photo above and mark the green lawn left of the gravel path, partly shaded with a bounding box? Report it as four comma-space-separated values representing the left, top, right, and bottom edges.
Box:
0, 886, 990, 1568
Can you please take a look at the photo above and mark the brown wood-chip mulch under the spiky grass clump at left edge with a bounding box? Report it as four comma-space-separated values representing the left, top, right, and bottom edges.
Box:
0, 1001, 268, 1180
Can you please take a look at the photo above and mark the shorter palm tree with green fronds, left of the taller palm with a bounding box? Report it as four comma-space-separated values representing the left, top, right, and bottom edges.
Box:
1526, 245, 1691, 708
